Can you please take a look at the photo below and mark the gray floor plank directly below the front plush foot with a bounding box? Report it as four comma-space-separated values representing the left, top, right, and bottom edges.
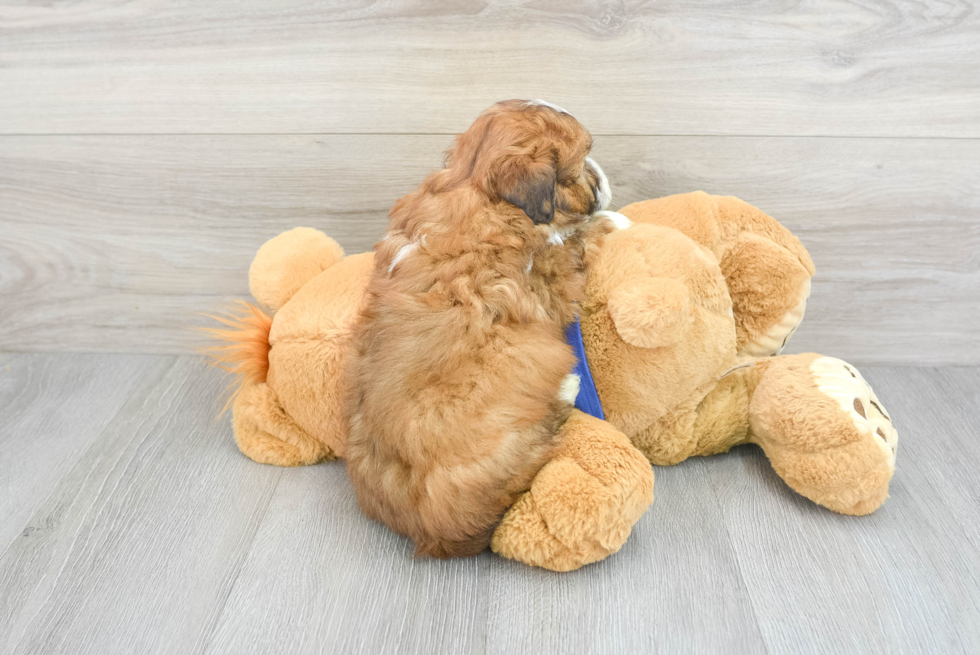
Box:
480, 460, 765, 654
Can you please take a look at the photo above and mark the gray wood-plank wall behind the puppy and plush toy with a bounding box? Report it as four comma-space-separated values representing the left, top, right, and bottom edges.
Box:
0, 0, 980, 365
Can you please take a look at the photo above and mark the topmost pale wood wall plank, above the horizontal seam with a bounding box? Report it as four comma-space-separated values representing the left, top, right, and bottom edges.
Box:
0, 0, 980, 137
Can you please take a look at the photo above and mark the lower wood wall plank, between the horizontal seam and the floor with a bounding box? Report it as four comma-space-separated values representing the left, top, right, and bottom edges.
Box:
0, 135, 980, 364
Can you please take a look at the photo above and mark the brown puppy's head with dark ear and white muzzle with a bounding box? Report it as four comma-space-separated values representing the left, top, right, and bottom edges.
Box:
447, 100, 611, 228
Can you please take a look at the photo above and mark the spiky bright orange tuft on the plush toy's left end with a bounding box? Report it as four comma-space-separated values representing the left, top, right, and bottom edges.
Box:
200, 300, 272, 415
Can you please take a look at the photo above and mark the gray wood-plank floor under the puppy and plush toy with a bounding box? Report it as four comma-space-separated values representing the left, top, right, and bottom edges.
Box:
0, 354, 980, 654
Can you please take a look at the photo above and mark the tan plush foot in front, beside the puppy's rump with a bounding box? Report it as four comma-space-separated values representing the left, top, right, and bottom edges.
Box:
491, 410, 653, 571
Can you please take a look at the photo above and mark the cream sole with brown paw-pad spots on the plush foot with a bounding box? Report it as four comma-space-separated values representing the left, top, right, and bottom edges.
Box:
810, 357, 898, 470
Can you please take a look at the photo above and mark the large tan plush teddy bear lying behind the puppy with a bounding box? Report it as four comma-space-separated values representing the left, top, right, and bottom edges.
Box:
211, 192, 897, 570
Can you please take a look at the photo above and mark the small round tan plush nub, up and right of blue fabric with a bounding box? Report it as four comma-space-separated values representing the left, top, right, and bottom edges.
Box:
608, 277, 693, 348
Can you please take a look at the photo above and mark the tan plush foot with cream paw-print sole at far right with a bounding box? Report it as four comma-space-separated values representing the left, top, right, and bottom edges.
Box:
749, 353, 898, 515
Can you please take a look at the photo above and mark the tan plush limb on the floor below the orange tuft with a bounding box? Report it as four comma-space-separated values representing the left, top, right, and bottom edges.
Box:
232, 382, 335, 466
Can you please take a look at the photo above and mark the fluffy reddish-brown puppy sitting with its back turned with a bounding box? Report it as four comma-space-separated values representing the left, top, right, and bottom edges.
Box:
347, 100, 612, 557
